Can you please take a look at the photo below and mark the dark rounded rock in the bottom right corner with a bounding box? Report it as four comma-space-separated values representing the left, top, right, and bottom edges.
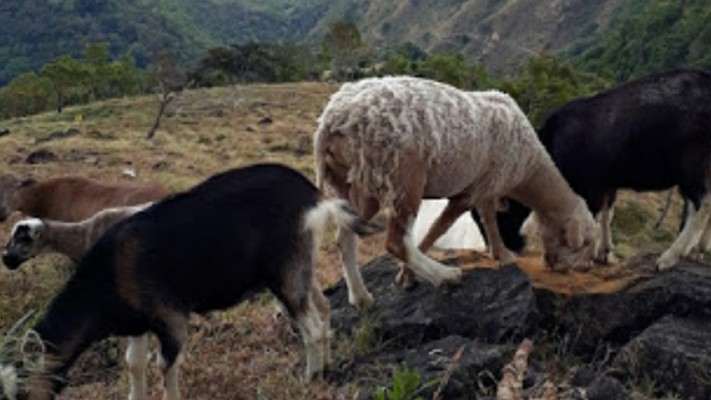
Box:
613, 316, 711, 400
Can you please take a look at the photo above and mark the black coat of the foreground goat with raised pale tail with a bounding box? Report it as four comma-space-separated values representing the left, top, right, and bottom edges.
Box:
29, 164, 320, 394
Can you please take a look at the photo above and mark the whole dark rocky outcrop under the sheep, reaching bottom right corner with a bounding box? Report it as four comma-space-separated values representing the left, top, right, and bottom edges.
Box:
327, 256, 711, 400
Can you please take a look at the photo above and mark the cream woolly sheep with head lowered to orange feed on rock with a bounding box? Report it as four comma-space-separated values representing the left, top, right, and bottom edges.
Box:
314, 77, 596, 306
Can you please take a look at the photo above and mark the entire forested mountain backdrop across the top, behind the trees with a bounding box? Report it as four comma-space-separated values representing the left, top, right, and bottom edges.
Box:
0, 0, 711, 85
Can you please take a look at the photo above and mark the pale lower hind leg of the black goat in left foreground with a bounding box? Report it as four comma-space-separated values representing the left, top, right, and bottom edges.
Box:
296, 296, 329, 381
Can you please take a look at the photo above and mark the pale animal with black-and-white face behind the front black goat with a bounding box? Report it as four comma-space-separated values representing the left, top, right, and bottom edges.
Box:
2, 203, 152, 269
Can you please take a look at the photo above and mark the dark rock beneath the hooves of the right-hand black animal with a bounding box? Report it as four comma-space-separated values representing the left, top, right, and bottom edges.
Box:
536, 262, 711, 354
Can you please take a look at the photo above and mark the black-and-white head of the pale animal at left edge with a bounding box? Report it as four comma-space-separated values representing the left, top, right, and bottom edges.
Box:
2, 218, 45, 269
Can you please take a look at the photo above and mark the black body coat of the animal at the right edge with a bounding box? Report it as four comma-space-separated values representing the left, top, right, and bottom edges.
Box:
472, 69, 711, 250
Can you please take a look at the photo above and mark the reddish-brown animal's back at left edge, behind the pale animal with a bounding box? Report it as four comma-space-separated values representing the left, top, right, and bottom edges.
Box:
0, 174, 168, 222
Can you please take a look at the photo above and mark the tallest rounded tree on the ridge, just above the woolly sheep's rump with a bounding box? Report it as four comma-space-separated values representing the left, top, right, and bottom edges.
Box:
321, 21, 368, 80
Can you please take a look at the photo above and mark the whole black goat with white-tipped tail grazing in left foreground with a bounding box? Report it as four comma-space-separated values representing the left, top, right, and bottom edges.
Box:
0, 164, 376, 400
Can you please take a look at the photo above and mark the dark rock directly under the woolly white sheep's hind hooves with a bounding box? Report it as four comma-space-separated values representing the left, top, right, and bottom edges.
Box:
327, 256, 538, 347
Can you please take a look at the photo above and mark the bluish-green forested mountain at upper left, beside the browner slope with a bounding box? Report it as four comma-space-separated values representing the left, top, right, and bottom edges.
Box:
0, 0, 325, 84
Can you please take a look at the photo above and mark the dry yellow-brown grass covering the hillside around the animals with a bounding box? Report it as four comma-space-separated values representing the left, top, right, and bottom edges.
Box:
0, 83, 678, 399
